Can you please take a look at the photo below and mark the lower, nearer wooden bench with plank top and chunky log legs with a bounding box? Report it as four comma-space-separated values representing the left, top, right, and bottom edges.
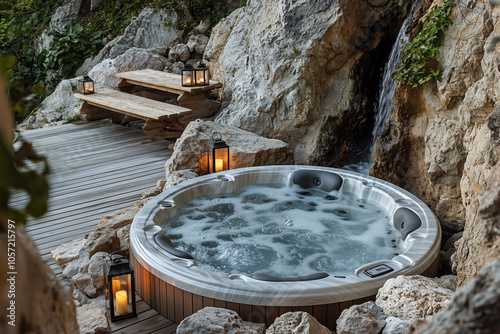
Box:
74, 88, 192, 139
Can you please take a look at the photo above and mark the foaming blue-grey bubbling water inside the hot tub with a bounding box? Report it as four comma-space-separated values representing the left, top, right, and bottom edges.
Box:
163, 184, 402, 277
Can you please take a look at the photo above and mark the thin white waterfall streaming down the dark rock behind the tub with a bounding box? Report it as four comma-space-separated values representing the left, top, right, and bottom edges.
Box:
344, 1, 416, 174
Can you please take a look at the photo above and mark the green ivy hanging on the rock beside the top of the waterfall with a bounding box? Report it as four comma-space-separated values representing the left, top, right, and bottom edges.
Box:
393, 0, 455, 87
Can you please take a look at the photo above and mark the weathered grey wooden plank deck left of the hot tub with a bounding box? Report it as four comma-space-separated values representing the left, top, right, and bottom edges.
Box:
11, 122, 177, 334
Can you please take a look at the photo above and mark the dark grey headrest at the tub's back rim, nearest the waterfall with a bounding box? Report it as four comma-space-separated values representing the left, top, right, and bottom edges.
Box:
292, 170, 343, 192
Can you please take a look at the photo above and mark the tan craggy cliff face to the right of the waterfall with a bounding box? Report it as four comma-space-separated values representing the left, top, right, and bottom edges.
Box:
371, 0, 500, 285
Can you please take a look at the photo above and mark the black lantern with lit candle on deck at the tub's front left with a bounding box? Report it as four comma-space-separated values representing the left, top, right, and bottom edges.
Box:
103, 251, 137, 321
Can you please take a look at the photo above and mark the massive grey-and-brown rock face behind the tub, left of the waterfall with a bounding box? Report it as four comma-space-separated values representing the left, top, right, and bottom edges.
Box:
204, 0, 407, 166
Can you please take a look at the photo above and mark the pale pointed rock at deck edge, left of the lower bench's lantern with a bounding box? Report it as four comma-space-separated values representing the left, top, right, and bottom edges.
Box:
22, 78, 82, 129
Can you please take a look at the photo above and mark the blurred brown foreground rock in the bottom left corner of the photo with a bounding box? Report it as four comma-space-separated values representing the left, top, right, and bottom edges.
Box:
0, 223, 78, 334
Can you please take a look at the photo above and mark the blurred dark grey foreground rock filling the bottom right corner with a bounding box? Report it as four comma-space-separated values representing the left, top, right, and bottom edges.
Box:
419, 260, 500, 334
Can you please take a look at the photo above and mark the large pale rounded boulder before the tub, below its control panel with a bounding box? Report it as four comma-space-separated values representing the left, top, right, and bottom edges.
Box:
376, 275, 453, 321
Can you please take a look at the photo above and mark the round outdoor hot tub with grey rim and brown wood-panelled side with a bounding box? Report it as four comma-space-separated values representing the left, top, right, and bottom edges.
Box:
130, 166, 441, 330
